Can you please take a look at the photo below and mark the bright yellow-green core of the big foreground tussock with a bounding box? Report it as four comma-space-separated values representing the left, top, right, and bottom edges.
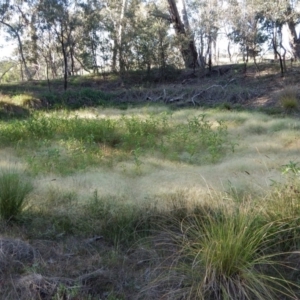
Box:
163, 206, 295, 299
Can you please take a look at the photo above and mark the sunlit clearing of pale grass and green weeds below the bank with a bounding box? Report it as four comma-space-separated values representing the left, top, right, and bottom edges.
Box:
0, 107, 300, 209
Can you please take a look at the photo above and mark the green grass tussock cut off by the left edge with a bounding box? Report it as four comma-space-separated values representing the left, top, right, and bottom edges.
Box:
0, 170, 33, 220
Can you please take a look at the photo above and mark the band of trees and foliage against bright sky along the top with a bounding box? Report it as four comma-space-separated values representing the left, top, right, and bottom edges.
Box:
0, 0, 300, 84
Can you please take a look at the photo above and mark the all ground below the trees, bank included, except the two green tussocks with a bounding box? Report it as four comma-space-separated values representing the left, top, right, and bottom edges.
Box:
0, 64, 300, 300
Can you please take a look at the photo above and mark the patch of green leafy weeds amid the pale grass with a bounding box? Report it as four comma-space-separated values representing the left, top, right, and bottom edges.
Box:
0, 113, 233, 174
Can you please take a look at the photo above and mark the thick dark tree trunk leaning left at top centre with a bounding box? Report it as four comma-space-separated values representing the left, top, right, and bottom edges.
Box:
168, 0, 198, 68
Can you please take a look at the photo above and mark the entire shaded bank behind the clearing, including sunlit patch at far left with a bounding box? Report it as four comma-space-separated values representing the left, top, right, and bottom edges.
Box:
1, 63, 300, 114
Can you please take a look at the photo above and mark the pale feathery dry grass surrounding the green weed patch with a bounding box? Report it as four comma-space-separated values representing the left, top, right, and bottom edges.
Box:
0, 107, 300, 210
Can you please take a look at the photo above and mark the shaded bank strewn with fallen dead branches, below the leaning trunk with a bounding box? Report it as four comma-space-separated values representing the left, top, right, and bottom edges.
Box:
75, 63, 300, 111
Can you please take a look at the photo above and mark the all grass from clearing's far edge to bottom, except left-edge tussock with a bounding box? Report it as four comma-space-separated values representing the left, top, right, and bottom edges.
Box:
0, 101, 300, 299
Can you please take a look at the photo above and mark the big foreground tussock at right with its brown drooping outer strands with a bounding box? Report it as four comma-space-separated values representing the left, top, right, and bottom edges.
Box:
144, 184, 299, 300
